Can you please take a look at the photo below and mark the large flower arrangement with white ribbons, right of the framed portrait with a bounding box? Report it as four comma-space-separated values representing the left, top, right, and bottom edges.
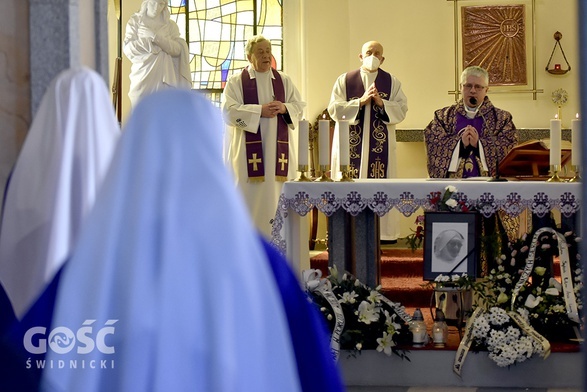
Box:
467, 229, 583, 366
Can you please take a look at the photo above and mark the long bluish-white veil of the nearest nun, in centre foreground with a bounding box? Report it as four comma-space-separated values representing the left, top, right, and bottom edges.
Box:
42, 90, 308, 392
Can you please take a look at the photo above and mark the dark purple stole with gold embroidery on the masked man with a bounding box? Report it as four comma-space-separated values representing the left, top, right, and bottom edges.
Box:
346, 69, 391, 178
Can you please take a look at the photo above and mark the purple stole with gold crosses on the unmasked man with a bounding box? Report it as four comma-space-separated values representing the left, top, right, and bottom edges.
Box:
241, 68, 289, 182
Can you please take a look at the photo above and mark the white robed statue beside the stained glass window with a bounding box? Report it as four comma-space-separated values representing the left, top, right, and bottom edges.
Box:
124, 0, 192, 107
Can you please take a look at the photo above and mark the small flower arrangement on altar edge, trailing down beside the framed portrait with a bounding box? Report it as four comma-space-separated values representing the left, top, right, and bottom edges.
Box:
406, 185, 470, 251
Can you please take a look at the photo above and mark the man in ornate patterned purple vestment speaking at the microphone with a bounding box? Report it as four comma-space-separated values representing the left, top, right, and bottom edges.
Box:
424, 66, 518, 178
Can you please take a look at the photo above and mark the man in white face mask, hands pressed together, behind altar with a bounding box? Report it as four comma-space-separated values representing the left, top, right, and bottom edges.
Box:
328, 41, 408, 241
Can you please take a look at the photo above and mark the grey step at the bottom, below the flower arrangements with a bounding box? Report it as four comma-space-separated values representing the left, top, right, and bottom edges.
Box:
339, 349, 584, 391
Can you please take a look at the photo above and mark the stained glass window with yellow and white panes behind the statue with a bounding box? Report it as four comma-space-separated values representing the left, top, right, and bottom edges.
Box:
169, 0, 283, 101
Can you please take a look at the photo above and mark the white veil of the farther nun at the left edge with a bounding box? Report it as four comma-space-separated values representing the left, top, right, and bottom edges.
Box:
0, 67, 120, 329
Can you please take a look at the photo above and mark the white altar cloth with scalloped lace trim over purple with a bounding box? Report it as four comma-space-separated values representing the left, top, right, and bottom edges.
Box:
272, 179, 581, 272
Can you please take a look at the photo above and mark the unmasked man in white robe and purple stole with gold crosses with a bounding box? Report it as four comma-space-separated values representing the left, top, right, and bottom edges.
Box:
222, 35, 306, 237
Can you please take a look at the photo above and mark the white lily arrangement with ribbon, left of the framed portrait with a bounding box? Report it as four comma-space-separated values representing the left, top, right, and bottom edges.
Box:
309, 266, 412, 360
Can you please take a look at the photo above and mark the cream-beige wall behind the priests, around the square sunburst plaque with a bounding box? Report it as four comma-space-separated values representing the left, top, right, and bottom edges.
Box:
104, 0, 580, 235
